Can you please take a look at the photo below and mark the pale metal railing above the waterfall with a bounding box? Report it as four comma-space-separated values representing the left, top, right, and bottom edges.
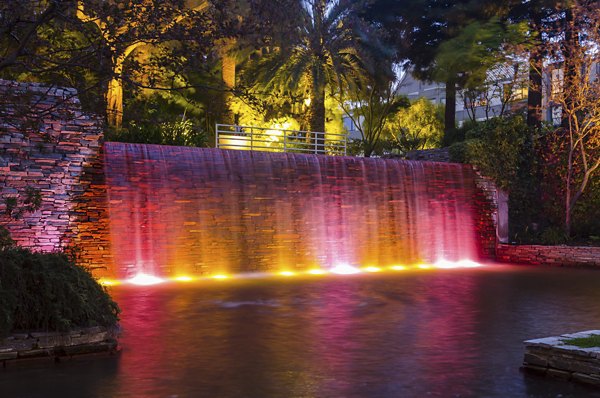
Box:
215, 124, 348, 155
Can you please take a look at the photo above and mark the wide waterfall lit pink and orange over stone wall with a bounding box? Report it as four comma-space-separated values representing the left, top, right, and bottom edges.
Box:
105, 143, 478, 278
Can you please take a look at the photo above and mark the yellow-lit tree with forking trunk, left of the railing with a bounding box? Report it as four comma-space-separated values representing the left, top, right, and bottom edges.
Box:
77, 0, 209, 128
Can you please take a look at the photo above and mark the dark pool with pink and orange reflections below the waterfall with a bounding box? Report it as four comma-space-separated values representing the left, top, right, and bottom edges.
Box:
0, 266, 600, 398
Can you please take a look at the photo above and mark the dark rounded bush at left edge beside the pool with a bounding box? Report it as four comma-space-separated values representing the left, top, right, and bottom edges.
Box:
0, 248, 120, 336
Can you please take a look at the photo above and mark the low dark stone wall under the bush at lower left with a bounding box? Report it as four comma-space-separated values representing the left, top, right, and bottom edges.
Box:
0, 327, 119, 367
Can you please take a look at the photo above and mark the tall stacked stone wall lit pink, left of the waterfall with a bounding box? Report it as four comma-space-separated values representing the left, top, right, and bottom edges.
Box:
0, 80, 108, 270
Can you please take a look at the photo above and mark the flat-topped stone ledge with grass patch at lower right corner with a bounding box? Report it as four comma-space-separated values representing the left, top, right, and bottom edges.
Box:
523, 330, 600, 387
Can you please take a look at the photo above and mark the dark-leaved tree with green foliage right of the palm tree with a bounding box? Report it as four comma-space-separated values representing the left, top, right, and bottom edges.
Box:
363, 0, 507, 138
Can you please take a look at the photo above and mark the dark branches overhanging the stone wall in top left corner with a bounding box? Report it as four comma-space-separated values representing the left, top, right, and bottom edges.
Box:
0, 0, 104, 116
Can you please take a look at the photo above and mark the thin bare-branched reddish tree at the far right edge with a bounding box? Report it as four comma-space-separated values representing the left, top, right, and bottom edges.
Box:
547, 0, 600, 236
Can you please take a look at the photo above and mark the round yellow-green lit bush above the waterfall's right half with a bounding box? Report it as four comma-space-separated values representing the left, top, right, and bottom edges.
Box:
387, 98, 444, 153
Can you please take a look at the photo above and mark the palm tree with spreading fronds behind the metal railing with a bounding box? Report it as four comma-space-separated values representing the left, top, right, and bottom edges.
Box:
246, 0, 386, 144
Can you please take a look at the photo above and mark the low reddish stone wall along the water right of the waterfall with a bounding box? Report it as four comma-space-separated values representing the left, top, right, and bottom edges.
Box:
496, 244, 600, 267
